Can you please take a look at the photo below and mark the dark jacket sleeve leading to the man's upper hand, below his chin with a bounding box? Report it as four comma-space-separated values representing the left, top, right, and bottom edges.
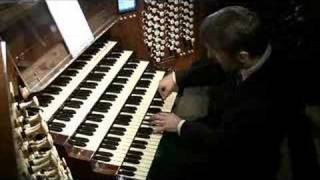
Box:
176, 60, 225, 89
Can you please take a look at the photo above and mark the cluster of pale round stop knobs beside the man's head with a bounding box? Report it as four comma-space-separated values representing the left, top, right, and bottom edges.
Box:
142, 0, 194, 62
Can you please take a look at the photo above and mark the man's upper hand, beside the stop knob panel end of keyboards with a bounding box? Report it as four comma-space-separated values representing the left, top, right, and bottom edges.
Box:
158, 73, 176, 99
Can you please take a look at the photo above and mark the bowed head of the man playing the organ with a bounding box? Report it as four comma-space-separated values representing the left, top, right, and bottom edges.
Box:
200, 6, 269, 71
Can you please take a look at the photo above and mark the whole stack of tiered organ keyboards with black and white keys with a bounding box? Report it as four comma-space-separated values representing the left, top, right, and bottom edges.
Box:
38, 36, 179, 179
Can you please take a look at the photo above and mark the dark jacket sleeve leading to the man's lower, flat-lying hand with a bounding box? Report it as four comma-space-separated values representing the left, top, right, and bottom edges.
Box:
180, 97, 279, 150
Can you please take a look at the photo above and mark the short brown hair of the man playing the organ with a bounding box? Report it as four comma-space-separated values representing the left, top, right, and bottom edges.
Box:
200, 6, 269, 56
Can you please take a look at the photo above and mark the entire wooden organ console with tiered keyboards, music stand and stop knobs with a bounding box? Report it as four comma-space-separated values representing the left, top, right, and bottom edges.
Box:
0, 0, 310, 180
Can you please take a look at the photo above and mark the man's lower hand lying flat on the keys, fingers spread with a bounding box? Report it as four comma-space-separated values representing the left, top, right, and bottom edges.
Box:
151, 113, 181, 133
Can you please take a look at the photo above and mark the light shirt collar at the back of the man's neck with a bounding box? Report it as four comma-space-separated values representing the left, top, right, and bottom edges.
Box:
240, 44, 272, 81
